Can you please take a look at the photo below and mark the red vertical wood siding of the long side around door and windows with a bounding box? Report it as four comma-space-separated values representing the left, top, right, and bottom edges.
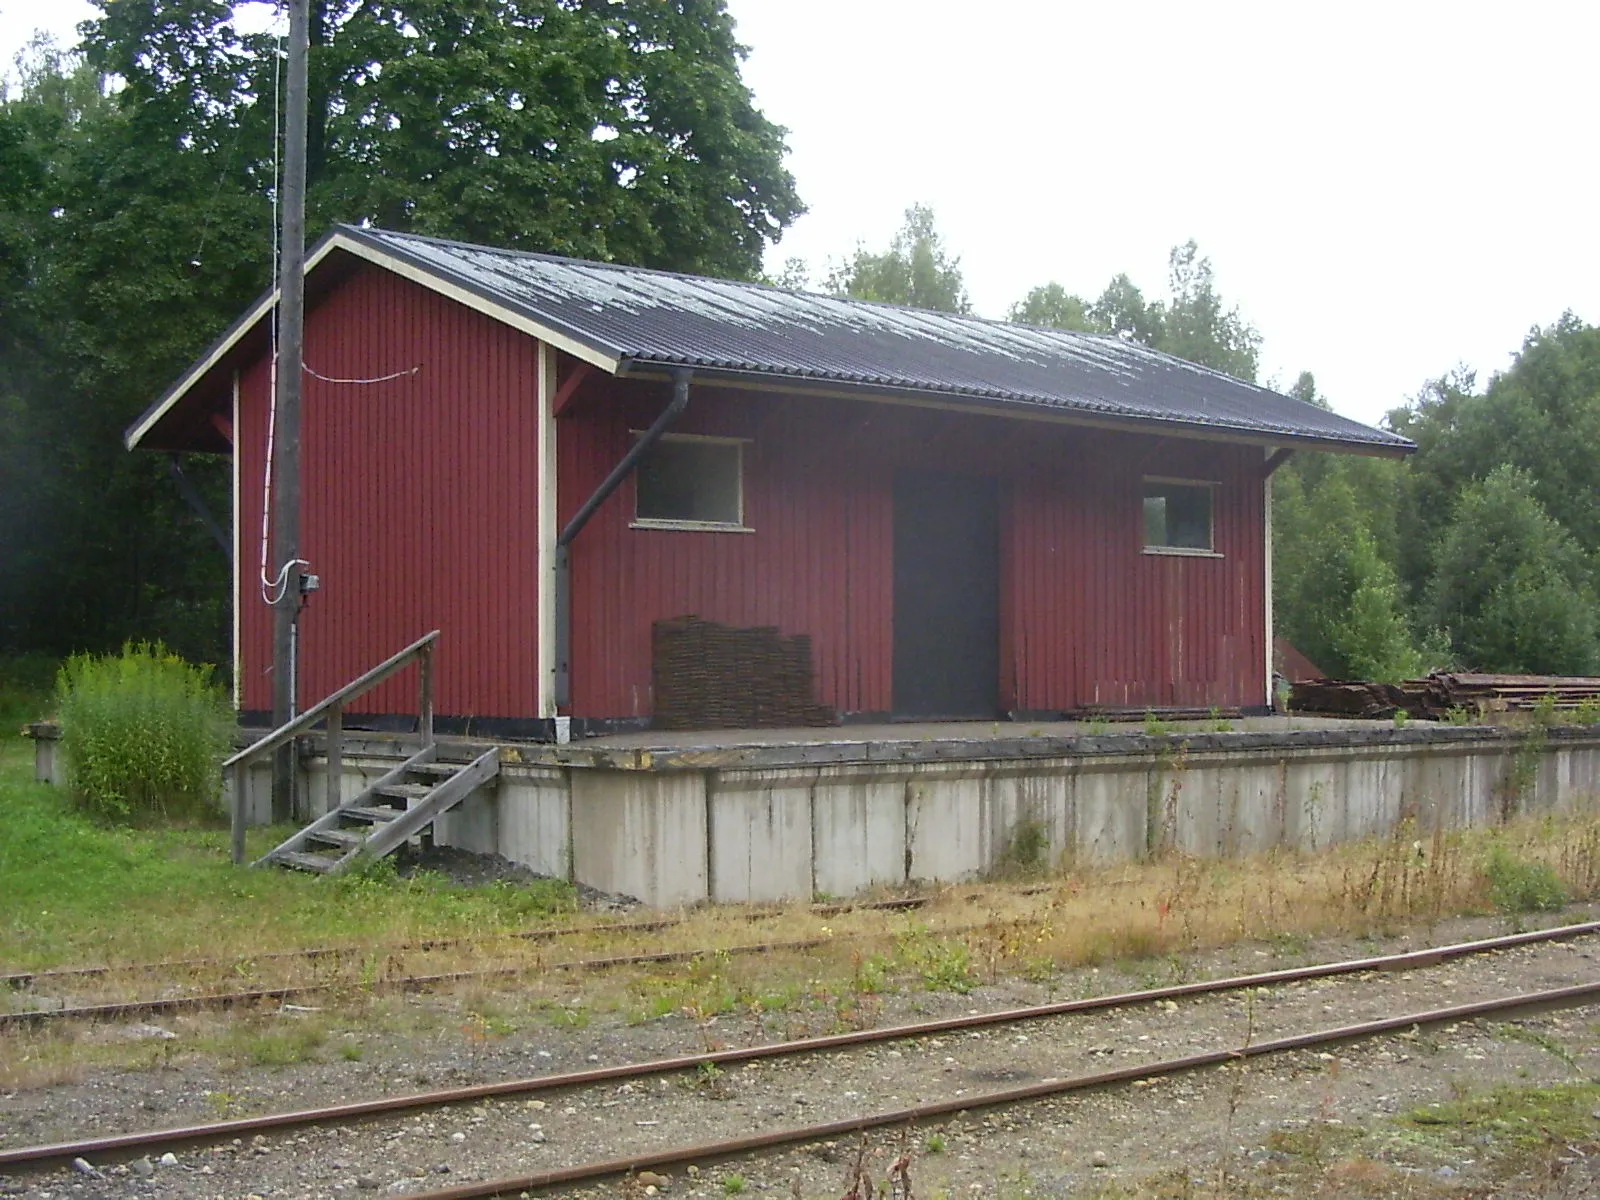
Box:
557, 378, 1266, 717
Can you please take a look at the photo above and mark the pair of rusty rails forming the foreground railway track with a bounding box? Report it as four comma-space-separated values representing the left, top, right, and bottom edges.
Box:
0, 922, 1600, 1177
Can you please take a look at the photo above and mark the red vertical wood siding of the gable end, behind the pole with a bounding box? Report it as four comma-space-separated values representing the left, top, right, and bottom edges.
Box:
237, 269, 539, 717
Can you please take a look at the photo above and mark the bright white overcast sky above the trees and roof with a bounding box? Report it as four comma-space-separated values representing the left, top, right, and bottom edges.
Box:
0, 0, 1600, 421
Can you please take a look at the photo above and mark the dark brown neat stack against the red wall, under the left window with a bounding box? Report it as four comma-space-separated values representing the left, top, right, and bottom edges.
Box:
651, 616, 838, 730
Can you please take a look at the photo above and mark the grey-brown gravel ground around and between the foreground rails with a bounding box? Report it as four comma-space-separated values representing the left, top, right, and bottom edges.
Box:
0, 910, 1600, 1200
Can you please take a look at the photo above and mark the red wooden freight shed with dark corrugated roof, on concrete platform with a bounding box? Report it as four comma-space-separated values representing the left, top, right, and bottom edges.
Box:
126, 227, 1411, 736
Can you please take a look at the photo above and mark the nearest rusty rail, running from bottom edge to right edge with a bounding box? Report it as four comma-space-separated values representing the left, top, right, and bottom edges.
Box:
410, 982, 1600, 1200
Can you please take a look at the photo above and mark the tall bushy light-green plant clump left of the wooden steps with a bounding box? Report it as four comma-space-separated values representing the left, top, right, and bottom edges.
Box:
56, 643, 234, 821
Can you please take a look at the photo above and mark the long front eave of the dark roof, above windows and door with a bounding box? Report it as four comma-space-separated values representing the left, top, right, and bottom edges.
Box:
616, 358, 1416, 458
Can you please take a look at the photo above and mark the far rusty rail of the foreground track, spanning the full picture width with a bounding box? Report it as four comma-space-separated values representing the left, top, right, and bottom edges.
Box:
0, 922, 1600, 1168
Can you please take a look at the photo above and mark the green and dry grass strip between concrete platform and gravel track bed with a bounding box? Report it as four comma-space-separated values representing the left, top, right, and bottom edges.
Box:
15, 713, 1600, 1086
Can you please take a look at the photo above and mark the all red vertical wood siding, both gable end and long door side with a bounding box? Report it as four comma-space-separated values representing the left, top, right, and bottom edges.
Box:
237, 259, 1266, 729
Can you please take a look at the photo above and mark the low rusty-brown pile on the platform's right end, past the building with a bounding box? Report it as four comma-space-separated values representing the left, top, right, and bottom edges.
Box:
1290, 672, 1600, 720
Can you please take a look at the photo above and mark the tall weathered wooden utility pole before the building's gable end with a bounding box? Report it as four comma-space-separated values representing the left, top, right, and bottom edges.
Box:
272, 0, 310, 822
